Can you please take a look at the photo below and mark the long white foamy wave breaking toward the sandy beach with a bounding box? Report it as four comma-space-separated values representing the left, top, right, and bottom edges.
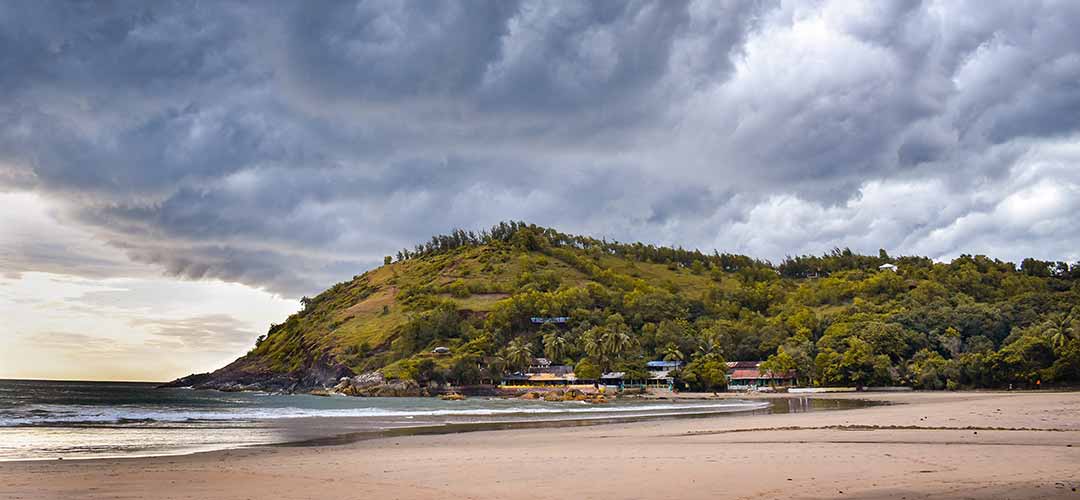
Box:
0, 402, 768, 427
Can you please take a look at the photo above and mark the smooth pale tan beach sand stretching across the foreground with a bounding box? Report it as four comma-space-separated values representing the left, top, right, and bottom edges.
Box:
0, 392, 1080, 500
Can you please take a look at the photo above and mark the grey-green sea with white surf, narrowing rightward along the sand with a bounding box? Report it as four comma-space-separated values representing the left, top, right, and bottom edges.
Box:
0, 380, 859, 461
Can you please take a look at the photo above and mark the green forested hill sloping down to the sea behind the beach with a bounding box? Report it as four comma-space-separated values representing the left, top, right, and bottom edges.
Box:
181, 222, 1080, 390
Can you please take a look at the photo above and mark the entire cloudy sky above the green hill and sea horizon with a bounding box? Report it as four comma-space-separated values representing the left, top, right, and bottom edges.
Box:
0, 0, 1080, 380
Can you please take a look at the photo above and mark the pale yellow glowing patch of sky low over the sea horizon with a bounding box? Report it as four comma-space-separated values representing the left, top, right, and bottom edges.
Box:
0, 272, 298, 381
